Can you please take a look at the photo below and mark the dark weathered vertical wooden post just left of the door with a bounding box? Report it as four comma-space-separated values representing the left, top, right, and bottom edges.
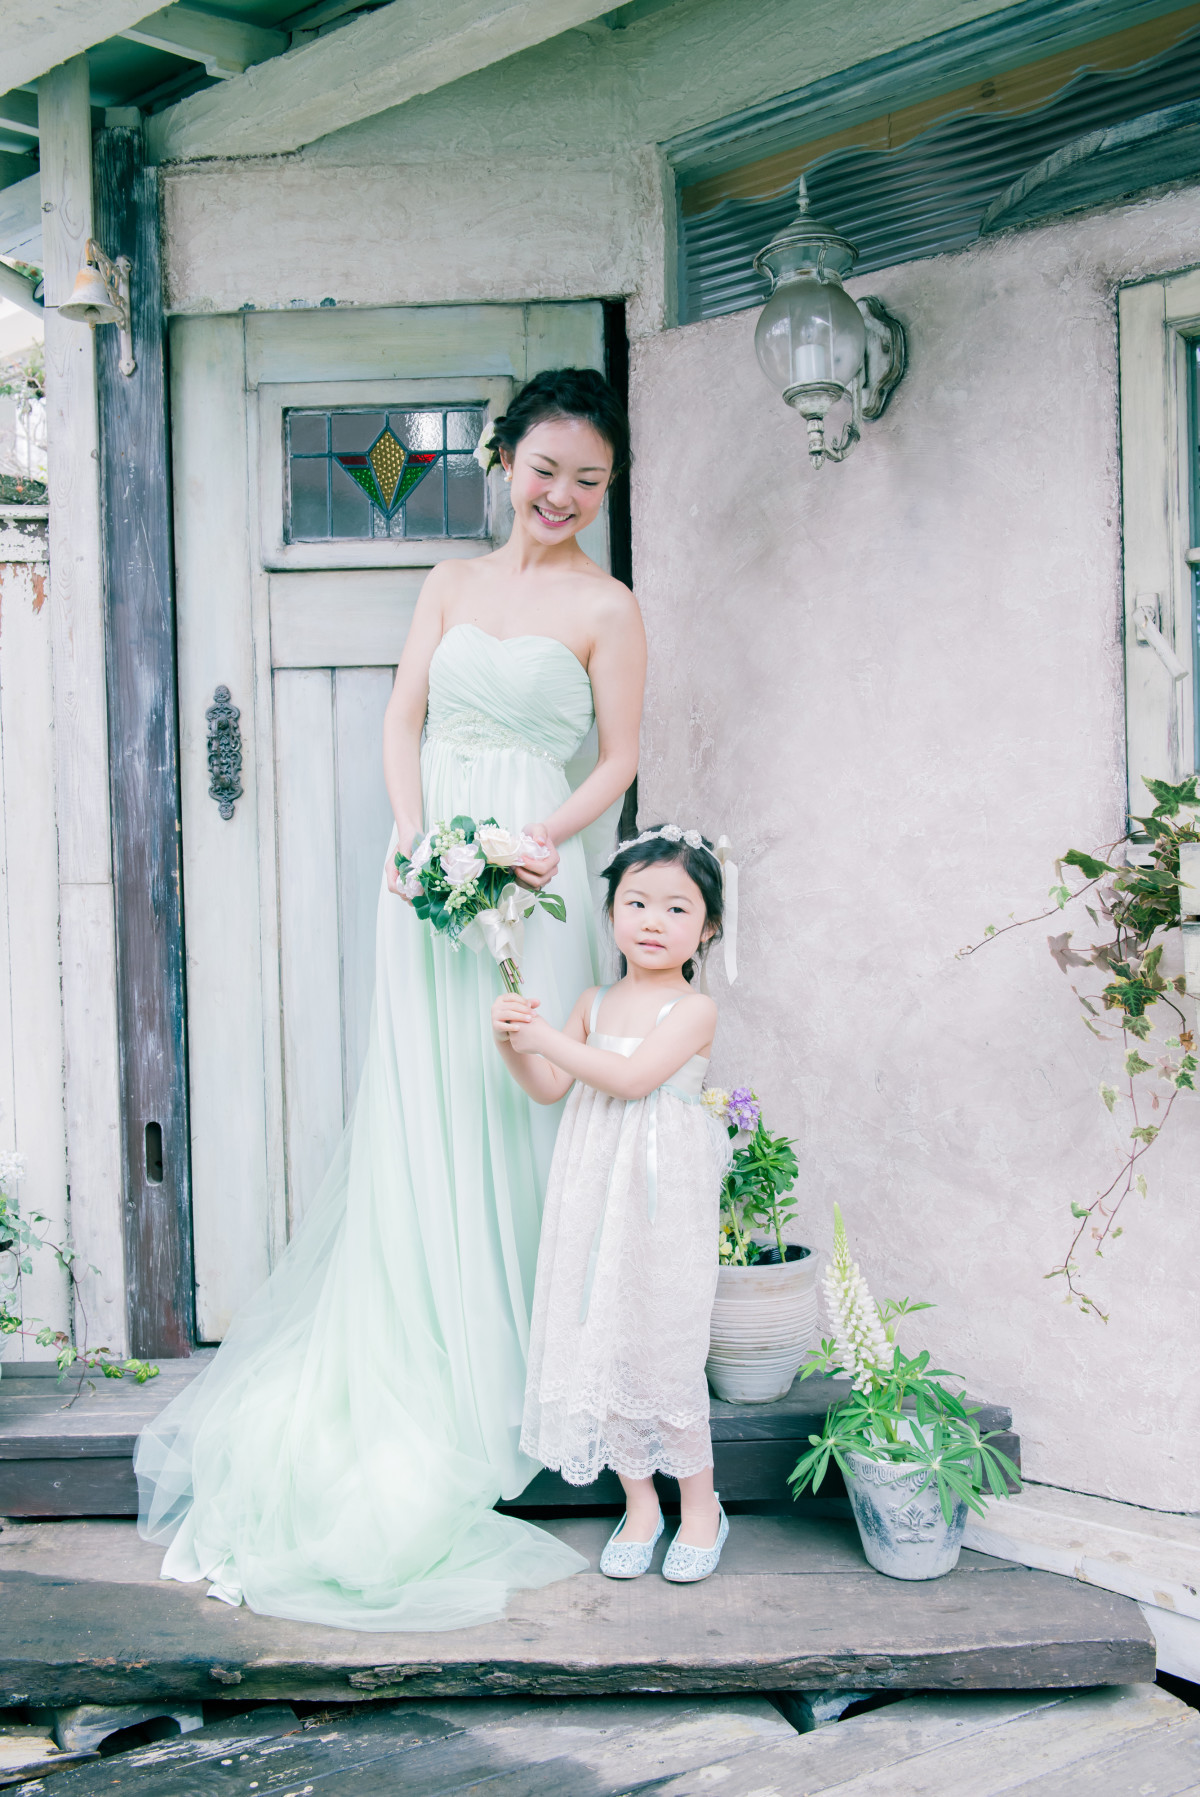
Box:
95, 129, 192, 1357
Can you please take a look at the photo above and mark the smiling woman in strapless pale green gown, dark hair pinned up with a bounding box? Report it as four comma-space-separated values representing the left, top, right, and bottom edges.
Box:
135, 368, 645, 1630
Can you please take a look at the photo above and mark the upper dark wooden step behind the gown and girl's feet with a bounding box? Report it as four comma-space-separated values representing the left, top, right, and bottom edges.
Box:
0, 1350, 1020, 1517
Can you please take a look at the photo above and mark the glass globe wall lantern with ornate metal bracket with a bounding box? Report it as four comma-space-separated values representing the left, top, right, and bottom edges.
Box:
754, 174, 905, 467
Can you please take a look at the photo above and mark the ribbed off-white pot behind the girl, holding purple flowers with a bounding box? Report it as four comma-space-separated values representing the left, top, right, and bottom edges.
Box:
704, 1249, 817, 1403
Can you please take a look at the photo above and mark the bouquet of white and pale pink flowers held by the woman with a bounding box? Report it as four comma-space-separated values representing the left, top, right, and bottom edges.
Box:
395, 818, 566, 992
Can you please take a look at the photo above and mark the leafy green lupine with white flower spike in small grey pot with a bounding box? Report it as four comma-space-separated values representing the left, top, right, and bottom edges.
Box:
789, 1204, 1020, 1522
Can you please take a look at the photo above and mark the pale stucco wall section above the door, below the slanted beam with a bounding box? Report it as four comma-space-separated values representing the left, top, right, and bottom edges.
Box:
163, 0, 1013, 338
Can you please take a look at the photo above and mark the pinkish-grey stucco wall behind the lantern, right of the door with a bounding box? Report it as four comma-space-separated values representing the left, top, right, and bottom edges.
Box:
632, 190, 1200, 1509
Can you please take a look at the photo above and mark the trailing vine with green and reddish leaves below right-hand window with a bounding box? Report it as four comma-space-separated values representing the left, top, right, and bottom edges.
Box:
959, 775, 1200, 1323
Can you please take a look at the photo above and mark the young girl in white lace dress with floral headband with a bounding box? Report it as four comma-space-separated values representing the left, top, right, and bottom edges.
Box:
492, 825, 729, 1583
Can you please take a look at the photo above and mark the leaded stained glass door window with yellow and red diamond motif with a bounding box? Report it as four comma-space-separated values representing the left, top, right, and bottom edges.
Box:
286, 406, 487, 543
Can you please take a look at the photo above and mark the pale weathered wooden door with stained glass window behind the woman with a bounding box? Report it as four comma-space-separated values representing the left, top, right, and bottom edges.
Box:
171, 304, 607, 1341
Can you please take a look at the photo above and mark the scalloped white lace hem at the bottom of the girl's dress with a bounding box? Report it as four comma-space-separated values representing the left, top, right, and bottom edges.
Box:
521, 1403, 713, 1484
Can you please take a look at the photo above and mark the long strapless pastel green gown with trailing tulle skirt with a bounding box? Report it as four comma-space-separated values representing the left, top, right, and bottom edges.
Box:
135, 625, 610, 1630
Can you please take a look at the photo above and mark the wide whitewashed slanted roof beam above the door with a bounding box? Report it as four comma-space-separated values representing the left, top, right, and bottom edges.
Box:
149, 0, 607, 162
